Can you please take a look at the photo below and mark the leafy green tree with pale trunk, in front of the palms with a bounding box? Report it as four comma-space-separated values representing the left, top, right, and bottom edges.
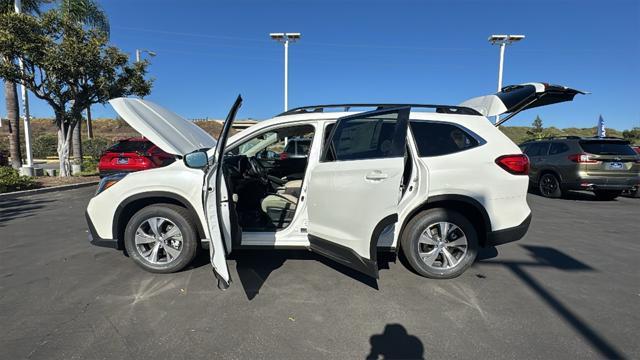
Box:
0, 11, 152, 176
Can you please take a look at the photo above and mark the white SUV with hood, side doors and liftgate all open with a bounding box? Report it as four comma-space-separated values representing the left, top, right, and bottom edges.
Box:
87, 83, 580, 288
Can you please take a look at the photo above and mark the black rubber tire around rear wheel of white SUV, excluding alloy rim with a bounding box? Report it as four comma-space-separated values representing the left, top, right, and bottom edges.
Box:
400, 208, 479, 279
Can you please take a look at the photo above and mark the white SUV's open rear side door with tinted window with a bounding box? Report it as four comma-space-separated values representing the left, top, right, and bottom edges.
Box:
307, 107, 410, 278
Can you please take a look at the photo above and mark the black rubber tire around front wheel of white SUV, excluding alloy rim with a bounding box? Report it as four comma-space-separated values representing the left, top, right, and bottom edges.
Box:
124, 204, 198, 274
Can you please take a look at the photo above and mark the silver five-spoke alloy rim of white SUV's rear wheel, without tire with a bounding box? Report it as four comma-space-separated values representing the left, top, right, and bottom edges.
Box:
418, 221, 468, 270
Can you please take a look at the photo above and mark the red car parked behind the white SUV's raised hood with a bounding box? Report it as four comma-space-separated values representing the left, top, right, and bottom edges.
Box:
98, 138, 175, 177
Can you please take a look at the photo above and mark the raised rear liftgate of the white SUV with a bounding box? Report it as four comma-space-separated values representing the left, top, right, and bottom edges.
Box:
460, 83, 587, 116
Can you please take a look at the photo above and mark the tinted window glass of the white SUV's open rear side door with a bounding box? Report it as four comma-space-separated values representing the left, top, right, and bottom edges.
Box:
323, 109, 408, 161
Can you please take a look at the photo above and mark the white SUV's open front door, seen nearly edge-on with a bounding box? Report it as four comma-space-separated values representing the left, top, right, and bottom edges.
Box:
204, 95, 242, 290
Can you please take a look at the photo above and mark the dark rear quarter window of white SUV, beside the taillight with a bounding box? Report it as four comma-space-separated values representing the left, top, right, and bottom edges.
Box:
409, 121, 479, 157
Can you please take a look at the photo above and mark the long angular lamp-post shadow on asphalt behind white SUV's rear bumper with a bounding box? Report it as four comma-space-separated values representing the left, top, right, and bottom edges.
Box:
482, 245, 625, 359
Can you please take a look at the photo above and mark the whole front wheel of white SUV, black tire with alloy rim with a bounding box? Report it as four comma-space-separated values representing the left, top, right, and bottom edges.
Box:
124, 204, 198, 274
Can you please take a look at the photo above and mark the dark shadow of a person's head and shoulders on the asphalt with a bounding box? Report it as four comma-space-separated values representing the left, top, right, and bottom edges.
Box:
366, 324, 424, 360
